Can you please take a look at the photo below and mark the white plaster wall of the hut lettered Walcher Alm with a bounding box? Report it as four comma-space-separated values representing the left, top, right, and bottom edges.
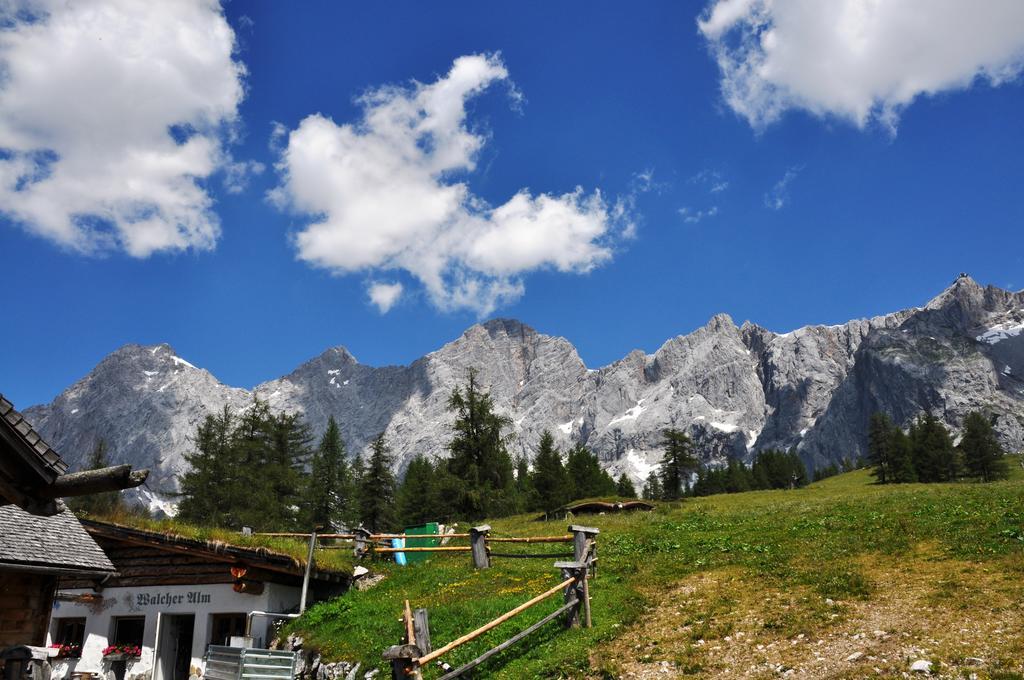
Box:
46, 583, 301, 680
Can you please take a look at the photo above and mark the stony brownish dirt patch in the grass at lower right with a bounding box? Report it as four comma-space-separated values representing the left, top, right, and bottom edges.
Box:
591, 548, 1024, 680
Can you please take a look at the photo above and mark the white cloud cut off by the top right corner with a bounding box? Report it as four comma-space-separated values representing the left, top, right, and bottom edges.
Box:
697, 0, 1024, 132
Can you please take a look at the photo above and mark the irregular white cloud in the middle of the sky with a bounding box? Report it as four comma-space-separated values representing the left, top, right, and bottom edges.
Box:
270, 55, 631, 315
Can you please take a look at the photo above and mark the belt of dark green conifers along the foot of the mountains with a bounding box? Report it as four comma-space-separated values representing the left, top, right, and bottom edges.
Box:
172, 371, 1008, 532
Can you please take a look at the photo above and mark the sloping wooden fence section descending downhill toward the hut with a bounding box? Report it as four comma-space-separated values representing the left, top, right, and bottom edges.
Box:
384, 525, 600, 680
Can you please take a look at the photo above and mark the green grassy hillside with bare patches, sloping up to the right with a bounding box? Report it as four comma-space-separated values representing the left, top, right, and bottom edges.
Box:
290, 462, 1024, 678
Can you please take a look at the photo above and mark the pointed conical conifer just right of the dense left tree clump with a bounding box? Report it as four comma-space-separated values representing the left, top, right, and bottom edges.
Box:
305, 416, 355, 527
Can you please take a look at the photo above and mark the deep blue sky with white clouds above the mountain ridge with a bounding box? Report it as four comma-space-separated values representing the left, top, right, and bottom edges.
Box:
0, 0, 1024, 407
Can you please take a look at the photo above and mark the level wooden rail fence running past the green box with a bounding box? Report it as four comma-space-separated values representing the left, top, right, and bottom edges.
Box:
257, 524, 597, 569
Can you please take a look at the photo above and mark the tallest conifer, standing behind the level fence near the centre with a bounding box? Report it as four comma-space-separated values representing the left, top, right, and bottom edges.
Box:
447, 370, 515, 519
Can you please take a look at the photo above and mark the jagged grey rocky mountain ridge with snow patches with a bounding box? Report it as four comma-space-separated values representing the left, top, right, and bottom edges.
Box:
19, 277, 1024, 510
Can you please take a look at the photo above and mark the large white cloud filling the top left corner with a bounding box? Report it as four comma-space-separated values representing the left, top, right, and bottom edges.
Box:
0, 0, 245, 257
